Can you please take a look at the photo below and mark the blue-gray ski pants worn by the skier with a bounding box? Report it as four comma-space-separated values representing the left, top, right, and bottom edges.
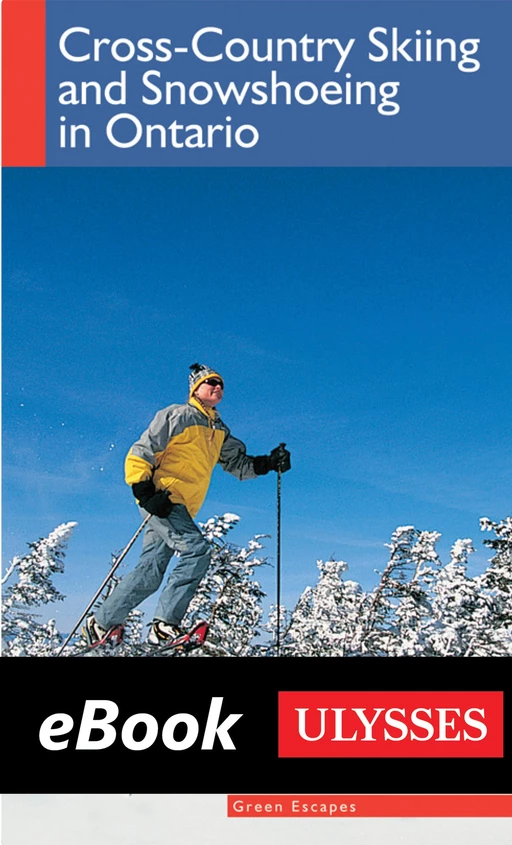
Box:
94, 505, 211, 629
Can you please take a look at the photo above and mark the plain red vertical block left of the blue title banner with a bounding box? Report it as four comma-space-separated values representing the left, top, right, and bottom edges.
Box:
2, 0, 46, 167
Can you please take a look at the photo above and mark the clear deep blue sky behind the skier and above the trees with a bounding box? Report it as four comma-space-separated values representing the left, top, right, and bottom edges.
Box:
3, 168, 512, 630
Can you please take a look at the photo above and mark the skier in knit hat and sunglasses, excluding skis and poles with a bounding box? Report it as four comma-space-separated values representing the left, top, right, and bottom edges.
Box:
85, 364, 291, 645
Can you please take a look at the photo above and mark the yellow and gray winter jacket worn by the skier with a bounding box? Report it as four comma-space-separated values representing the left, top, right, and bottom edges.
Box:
125, 397, 256, 516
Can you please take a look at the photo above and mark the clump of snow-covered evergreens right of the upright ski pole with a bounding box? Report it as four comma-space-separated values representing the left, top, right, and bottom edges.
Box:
281, 518, 512, 657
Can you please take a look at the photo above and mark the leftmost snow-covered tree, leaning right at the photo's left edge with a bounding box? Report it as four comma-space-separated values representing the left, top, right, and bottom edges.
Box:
2, 522, 77, 657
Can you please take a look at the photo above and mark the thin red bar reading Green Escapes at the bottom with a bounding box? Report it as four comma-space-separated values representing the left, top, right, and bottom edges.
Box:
227, 795, 512, 818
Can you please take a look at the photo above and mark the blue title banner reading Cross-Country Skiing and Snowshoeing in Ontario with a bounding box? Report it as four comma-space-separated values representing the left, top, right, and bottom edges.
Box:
46, 0, 512, 167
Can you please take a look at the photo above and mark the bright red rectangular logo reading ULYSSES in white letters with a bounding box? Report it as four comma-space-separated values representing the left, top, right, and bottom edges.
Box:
279, 691, 503, 757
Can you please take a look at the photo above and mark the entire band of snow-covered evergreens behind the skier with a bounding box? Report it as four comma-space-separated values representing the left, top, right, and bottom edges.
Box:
2, 514, 512, 657
